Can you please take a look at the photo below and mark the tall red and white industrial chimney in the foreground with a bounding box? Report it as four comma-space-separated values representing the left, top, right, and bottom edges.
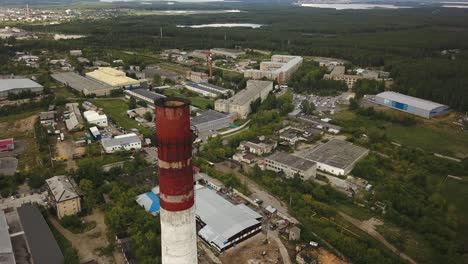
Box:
156, 98, 198, 264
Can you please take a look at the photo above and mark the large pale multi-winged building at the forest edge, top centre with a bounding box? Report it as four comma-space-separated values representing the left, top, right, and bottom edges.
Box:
244, 55, 303, 84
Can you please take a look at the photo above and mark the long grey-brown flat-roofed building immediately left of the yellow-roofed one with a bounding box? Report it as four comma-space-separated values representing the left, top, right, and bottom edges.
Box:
51, 72, 115, 96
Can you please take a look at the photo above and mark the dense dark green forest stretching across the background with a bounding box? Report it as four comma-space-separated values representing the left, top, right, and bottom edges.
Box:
12, 4, 468, 111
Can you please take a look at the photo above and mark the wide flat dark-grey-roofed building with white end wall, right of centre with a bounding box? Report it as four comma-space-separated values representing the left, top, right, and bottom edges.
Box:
303, 139, 369, 175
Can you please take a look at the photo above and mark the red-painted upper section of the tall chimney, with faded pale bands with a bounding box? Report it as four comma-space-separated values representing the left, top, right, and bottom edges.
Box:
155, 98, 194, 212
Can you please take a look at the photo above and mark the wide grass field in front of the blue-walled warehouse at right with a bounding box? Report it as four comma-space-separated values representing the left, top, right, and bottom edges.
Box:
332, 111, 468, 157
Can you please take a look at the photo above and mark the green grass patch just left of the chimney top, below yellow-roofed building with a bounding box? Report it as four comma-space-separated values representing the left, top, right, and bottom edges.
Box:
92, 99, 151, 136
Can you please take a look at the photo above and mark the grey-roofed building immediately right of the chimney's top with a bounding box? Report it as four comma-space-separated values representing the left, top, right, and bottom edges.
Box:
192, 109, 231, 133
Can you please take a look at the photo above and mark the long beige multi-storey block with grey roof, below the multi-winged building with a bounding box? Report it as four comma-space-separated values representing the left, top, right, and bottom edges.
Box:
215, 80, 273, 118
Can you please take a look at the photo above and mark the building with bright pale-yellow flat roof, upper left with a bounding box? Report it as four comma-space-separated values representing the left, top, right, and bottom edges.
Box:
86, 67, 140, 89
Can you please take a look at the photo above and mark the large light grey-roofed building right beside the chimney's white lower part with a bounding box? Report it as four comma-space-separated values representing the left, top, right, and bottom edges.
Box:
195, 187, 262, 252
